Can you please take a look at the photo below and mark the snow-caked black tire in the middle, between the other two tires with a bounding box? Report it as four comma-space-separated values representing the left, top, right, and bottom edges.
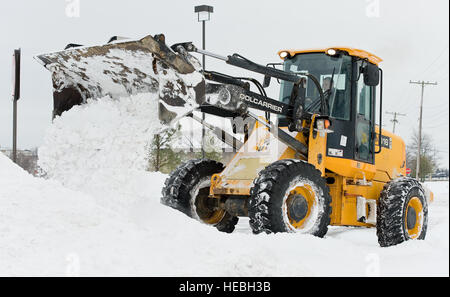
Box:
249, 159, 331, 237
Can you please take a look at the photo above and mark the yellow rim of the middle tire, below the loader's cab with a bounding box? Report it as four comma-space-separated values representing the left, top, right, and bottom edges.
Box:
285, 185, 317, 229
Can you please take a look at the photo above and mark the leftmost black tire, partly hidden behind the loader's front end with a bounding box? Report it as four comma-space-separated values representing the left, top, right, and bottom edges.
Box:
161, 159, 238, 233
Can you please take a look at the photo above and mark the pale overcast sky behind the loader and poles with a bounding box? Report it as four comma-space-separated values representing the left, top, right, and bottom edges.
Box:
0, 0, 449, 167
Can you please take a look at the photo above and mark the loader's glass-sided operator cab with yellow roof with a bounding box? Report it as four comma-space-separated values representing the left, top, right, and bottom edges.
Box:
278, 48, 381, 164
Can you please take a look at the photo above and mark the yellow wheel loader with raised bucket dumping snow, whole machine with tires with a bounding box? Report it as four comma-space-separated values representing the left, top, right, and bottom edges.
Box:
36, 35, 433, 246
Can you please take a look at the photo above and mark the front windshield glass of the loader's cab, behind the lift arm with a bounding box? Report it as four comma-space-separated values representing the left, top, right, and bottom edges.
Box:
280, 53, 351, 120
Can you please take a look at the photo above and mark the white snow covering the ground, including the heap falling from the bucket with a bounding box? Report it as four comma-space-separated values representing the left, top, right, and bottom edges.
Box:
0, 97, 449, 276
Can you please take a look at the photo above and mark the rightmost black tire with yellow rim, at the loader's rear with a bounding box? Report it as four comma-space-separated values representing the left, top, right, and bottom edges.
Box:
377, 177, 428, 247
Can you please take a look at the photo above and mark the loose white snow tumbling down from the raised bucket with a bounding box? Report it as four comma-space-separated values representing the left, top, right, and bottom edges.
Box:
39, 93, 161, 210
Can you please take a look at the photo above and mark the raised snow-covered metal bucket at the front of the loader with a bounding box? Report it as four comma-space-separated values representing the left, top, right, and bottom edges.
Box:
35, 34, 205, 124
